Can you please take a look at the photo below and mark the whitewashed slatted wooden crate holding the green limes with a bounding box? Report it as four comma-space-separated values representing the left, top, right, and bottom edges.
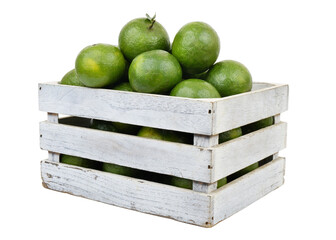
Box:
39, 80, 288, 227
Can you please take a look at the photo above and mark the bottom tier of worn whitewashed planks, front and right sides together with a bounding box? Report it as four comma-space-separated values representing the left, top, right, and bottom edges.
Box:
41, 158, 285, 227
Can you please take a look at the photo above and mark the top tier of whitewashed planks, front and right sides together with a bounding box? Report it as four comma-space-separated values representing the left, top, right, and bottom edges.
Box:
39, 83, 288, 135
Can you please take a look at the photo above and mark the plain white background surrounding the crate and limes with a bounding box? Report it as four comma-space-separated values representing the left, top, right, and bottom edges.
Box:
0, 0, 336, 239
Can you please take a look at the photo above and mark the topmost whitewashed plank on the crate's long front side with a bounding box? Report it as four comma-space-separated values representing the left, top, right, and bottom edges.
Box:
39, 83, 213, 135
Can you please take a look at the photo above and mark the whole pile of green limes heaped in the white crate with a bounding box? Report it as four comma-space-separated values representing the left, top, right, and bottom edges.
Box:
60, 14, 273, 188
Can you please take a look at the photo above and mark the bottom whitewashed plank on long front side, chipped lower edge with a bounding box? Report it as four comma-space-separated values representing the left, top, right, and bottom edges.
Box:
41, 161, 212, 227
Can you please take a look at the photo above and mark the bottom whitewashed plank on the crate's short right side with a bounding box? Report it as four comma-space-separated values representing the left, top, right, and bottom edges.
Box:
211, 158, 285, 224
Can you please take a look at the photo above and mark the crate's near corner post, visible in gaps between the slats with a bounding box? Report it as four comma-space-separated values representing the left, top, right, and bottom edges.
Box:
192, 134, 219, 193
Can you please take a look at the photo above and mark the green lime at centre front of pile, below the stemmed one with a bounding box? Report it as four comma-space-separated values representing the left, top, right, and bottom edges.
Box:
128, 50, 182, 94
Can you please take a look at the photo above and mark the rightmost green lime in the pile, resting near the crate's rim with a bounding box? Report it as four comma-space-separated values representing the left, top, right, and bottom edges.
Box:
206, 60, 252, 97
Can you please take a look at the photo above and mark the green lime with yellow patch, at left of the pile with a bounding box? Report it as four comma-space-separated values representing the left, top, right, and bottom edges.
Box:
75, 43, 126, 88
